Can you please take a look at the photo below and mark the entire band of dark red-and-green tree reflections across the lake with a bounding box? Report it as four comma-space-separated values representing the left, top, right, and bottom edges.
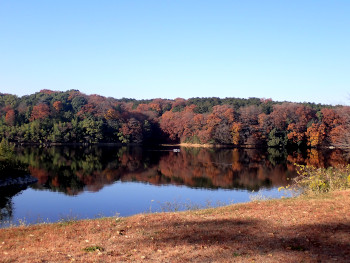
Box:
6, 146, 346, 195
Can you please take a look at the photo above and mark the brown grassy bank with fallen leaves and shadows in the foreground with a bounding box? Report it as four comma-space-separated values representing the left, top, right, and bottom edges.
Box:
0, 190, 350, 262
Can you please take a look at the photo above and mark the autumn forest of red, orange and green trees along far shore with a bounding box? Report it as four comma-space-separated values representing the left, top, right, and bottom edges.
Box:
0, 90, 350, 148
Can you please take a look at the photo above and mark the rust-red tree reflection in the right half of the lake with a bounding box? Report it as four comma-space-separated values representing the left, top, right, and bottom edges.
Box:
159, 149, 287, 190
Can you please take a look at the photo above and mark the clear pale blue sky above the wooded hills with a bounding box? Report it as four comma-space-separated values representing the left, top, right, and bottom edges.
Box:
0, 0, 350, 105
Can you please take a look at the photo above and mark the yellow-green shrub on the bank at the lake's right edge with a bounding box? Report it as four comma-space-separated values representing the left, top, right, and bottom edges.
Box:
293, 164, 350, 194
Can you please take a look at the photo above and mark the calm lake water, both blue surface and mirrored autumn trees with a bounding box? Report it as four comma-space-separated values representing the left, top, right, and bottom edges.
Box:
0, 146, 348, 226
